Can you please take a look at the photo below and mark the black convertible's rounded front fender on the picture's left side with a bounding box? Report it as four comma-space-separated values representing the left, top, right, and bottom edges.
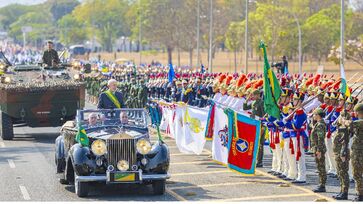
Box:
69, 143, 96, 176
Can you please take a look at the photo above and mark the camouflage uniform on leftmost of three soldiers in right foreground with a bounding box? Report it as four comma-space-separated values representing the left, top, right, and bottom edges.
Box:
311, 119, 327, 186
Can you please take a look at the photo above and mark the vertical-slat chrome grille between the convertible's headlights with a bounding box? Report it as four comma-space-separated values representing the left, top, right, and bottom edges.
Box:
106, 139, 137, 170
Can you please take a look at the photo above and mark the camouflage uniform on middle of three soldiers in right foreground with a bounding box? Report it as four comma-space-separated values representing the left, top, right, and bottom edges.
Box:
333, 111, 351, 196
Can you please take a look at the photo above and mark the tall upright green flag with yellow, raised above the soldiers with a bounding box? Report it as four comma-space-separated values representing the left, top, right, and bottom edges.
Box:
260, 41, 281, 119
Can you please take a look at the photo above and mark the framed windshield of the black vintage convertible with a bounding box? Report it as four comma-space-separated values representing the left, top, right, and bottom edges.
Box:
76, 109, 147, 129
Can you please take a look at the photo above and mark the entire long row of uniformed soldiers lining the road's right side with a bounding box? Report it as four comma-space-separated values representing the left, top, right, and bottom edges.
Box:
82, 66, 363, 200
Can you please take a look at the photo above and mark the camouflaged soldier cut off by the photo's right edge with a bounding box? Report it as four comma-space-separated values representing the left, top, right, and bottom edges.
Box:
351, 103, 363, 201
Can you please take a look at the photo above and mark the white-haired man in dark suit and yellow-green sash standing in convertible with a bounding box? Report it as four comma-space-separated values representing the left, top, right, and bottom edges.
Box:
97, 79, 125, 109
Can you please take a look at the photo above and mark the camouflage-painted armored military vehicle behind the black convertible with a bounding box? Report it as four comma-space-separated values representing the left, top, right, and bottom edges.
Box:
0, 52, 85, 140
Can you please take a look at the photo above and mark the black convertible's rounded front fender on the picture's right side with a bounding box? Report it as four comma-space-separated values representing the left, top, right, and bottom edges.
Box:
143, 142, 170, 173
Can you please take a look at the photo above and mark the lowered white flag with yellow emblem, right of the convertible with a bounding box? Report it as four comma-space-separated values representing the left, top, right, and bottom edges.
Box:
181, 106, 208, 154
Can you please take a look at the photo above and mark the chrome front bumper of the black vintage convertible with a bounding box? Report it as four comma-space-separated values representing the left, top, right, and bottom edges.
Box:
75, 172, 170, 183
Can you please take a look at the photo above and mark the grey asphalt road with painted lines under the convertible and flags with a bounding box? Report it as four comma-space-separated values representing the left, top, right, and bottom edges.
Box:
0, 102, 355, 201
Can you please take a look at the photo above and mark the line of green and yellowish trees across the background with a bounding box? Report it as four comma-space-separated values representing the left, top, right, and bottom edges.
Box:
0, 0, 363, 67
